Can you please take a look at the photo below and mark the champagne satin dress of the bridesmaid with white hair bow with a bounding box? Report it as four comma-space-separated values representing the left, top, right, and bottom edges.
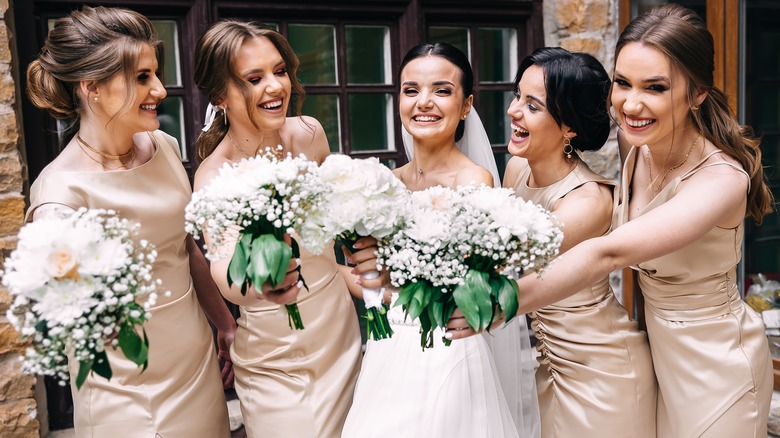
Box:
230, 246, 361, 438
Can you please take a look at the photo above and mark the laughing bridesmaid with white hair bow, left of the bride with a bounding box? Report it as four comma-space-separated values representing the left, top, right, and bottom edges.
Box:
195, 20, 368, 438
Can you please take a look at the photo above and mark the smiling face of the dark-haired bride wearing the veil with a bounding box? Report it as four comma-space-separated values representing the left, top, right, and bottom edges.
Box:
398, 56, 473, 145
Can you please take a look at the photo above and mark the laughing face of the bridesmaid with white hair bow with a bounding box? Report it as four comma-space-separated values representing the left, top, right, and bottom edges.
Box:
221, 37, 292, 130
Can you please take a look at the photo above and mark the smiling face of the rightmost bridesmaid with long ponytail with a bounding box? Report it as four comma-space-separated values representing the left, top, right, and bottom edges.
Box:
612, 43, 692, 146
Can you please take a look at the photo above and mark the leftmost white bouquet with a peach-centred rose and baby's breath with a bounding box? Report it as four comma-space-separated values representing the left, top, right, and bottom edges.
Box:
2, 208, 159, 388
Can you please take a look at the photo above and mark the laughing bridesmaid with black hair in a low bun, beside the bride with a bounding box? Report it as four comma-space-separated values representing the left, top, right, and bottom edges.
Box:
504, 48, 656, 438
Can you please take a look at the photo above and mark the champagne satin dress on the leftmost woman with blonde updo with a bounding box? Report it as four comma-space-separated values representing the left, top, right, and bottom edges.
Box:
27, 131, 230, 438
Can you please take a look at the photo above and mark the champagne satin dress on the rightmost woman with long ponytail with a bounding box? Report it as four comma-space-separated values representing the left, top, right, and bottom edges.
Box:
617, 148, 773, 438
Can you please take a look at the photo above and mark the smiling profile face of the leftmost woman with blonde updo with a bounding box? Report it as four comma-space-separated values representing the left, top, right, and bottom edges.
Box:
96, 45, 167, 134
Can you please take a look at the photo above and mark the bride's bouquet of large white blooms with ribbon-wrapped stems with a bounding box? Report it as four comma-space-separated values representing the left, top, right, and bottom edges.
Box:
302, 154, 409, 339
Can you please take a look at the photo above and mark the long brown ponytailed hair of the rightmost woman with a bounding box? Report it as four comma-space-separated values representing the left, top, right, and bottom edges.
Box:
615, 4, 774, 224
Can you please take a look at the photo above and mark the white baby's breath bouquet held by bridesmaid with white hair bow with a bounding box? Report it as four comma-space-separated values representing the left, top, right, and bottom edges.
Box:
185, 153, 324, 329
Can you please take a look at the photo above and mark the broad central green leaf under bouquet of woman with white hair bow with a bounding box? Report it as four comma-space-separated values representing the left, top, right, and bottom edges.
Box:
250, 234, 292, 288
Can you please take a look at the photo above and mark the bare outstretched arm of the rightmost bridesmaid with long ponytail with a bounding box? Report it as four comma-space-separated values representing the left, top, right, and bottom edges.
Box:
451, 161, 748, 339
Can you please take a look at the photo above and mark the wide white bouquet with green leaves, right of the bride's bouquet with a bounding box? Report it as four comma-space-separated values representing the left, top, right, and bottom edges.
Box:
379, 185, 563, 349
